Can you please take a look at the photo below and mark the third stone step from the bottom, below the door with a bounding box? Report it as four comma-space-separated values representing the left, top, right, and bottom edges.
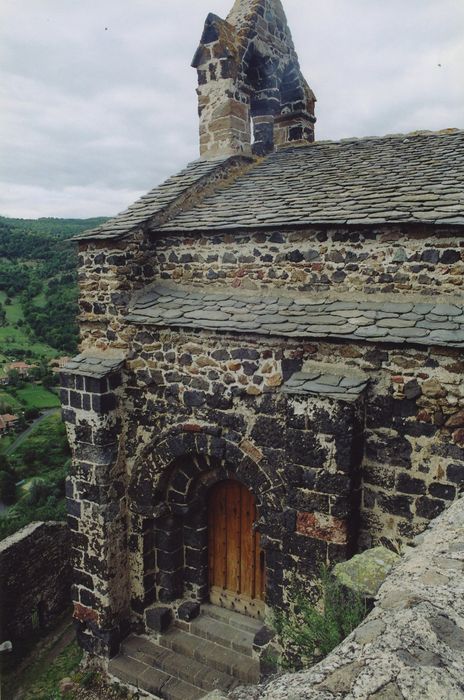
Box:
159, 627, 260, 683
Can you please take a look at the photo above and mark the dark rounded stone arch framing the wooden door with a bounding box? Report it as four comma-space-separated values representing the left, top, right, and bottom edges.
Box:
129, 425, 285, 607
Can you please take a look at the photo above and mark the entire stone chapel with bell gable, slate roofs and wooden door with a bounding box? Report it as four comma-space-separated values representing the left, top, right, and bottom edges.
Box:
62, 0, 464, 698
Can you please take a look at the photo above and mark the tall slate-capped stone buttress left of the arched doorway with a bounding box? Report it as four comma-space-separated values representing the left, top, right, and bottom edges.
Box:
61, 355, 130, 656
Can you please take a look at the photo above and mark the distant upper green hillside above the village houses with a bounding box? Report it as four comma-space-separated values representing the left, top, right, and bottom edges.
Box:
0, 217, 105, 356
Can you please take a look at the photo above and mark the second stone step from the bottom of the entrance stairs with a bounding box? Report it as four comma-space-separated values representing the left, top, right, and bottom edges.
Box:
121, 636, 238, 692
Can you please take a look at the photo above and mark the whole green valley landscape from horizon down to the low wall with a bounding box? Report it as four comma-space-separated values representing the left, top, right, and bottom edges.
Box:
0, 217, 106, 539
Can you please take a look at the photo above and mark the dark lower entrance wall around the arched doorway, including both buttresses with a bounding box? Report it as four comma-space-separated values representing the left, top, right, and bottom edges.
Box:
62, 348, 363, 636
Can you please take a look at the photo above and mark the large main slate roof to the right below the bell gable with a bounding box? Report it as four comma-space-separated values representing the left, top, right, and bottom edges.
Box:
160, 130, 464, 231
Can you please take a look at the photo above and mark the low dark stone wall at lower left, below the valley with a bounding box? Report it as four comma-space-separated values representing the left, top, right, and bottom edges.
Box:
0, 522, 71, 646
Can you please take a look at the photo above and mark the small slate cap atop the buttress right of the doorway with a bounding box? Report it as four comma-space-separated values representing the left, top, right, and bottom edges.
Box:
282, 364, 369, 401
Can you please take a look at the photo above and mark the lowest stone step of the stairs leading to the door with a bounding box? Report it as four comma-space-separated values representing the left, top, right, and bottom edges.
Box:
108, 655, 205, 700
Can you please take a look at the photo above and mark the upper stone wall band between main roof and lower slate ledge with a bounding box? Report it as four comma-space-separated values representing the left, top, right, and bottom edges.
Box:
147, 226, 464, 296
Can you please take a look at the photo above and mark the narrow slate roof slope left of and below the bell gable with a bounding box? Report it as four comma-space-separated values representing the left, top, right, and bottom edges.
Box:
73, 158, 239, 241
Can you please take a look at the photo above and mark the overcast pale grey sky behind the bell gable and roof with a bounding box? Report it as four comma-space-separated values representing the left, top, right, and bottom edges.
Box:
0, 0, 464, 218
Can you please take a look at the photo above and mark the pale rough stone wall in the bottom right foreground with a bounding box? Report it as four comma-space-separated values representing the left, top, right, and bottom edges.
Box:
227, 498, 464, 700
